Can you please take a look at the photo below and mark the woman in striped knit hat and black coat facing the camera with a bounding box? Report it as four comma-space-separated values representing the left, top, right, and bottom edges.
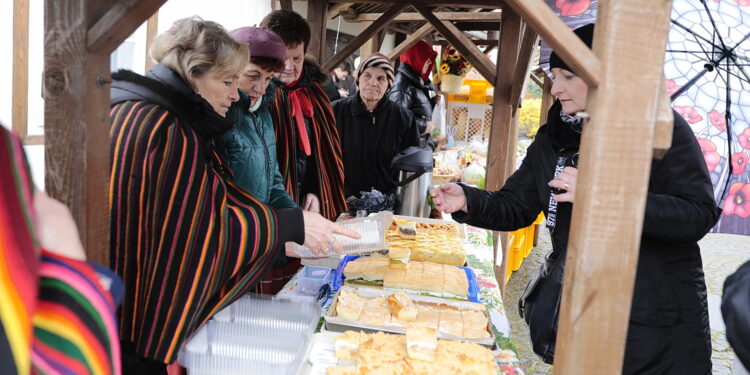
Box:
333, 53, 419, 197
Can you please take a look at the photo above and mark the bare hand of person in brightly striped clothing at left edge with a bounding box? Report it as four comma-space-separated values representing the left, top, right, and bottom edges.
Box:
34, 191, 86, 260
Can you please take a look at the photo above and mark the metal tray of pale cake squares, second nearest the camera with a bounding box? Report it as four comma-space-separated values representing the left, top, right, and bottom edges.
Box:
324, 285, 495, 347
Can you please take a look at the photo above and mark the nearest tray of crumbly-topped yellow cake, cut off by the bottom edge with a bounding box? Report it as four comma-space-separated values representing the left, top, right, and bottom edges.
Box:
308, 327, 499, 375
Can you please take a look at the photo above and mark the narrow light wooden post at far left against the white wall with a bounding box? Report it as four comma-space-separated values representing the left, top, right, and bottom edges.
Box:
11, 0, 29, 140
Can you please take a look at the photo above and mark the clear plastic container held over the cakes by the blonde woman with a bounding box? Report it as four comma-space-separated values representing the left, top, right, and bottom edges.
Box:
295, 212, 393, 258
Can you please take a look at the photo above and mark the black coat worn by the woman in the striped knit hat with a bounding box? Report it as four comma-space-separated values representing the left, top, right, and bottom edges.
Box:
332, 92, 419, 197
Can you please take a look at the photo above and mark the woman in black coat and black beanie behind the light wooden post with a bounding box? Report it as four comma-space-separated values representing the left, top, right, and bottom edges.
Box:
432, 25, 719, 375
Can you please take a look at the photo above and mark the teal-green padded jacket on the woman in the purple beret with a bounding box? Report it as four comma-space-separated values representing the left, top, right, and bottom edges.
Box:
216, 84, 297, 208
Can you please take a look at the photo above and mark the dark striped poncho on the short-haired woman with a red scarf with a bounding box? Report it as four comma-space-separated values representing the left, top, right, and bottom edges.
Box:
270, 62, 346, 220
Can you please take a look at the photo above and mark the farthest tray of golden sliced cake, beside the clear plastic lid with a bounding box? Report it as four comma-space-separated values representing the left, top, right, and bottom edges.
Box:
385, 215, 466, 266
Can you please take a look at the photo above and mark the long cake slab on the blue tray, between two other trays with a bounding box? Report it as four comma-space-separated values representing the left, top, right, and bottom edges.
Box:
333, 252, 479, 302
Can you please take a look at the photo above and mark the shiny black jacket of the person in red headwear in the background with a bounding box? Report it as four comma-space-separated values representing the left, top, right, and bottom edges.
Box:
388, 64, 434, 134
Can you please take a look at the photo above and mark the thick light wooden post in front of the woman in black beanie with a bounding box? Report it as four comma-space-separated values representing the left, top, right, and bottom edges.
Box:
554, 0, 671, 374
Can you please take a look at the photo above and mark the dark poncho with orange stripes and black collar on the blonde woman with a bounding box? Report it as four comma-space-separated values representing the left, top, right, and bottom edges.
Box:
110, 65, 304, 363
